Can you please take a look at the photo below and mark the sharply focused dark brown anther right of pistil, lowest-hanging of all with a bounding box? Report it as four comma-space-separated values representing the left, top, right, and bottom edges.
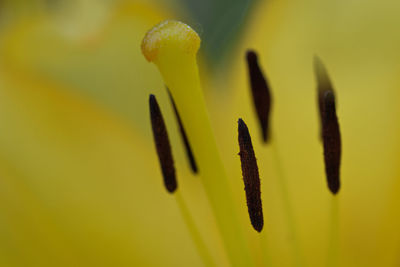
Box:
238, 119, 264, 232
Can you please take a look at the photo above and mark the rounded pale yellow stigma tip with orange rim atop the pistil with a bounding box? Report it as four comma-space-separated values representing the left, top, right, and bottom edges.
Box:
142, 20, 201, 62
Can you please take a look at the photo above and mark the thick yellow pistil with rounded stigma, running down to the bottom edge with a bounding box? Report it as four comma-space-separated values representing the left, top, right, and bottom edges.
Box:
142, 21, 253, 266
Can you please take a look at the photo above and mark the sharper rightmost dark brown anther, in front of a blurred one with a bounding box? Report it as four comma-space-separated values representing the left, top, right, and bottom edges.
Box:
322, 91, 342, 194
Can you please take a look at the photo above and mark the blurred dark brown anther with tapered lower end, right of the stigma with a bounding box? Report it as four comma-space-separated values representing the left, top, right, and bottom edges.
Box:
246, 50, 271, 143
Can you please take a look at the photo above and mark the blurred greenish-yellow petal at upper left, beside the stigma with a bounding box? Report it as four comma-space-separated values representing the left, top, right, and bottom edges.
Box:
2, 1, 171, 136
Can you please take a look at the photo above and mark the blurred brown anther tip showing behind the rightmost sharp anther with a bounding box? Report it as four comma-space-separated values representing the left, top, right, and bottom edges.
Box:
314, 56, 335, 137
